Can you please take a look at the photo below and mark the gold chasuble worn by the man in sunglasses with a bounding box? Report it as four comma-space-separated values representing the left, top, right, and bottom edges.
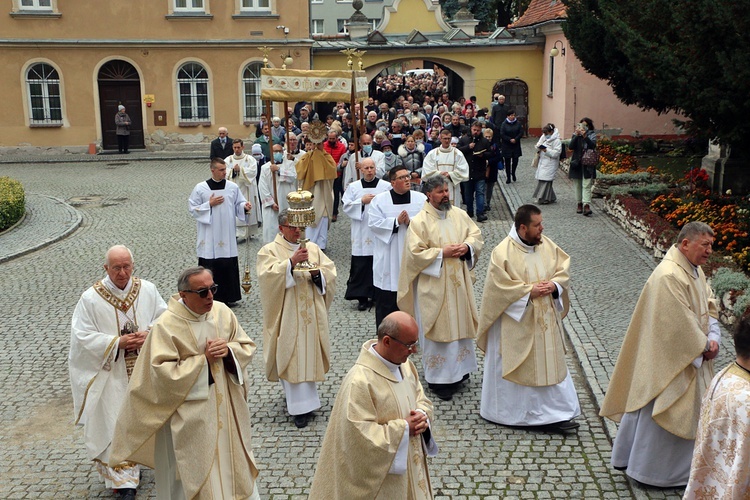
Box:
111, 295, 258, 500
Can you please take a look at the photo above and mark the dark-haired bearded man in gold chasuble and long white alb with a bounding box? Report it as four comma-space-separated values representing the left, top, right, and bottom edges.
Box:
477, 205, 581, 431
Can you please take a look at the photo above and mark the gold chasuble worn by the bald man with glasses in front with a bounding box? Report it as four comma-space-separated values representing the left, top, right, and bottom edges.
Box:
309, 340, 432, 500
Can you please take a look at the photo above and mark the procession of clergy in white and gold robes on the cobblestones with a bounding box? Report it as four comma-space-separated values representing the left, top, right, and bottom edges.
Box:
69, 119, 750, 499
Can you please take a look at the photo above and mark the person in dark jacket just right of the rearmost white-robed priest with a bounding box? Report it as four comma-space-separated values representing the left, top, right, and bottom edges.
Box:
458, 122, 492, 222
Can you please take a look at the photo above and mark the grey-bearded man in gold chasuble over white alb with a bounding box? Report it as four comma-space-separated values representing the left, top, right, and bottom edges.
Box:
398, 175, 484, 400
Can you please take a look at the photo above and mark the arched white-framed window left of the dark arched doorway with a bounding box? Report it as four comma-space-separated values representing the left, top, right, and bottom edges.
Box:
26, 63, 62, 125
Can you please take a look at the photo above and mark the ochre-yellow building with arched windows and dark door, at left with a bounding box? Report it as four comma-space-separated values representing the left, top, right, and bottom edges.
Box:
0, 0, 312, 151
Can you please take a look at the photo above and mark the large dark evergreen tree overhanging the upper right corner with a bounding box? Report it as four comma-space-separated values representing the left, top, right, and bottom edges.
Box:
563, 0, 750, 145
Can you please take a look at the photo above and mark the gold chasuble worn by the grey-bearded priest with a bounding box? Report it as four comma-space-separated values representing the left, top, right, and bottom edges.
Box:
398, 202, 484, 342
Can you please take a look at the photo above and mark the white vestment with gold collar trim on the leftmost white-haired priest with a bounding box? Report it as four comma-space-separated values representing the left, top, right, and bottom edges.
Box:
68, 276, 167, 488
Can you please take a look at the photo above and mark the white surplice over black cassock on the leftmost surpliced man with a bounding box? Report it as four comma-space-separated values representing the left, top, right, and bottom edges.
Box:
188, 181, 247, 259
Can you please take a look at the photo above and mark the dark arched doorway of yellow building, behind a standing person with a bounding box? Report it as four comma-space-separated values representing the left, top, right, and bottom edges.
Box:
97, 60, 145, 150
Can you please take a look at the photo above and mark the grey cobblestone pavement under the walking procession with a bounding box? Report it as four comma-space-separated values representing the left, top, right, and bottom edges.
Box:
0, 142, 728, 499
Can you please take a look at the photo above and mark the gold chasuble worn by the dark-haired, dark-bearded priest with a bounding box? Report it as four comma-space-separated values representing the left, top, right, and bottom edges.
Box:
477, 236, 570, 387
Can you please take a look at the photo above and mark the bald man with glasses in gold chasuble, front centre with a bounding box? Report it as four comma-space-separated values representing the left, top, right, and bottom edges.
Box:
310, 311, 438, 500
